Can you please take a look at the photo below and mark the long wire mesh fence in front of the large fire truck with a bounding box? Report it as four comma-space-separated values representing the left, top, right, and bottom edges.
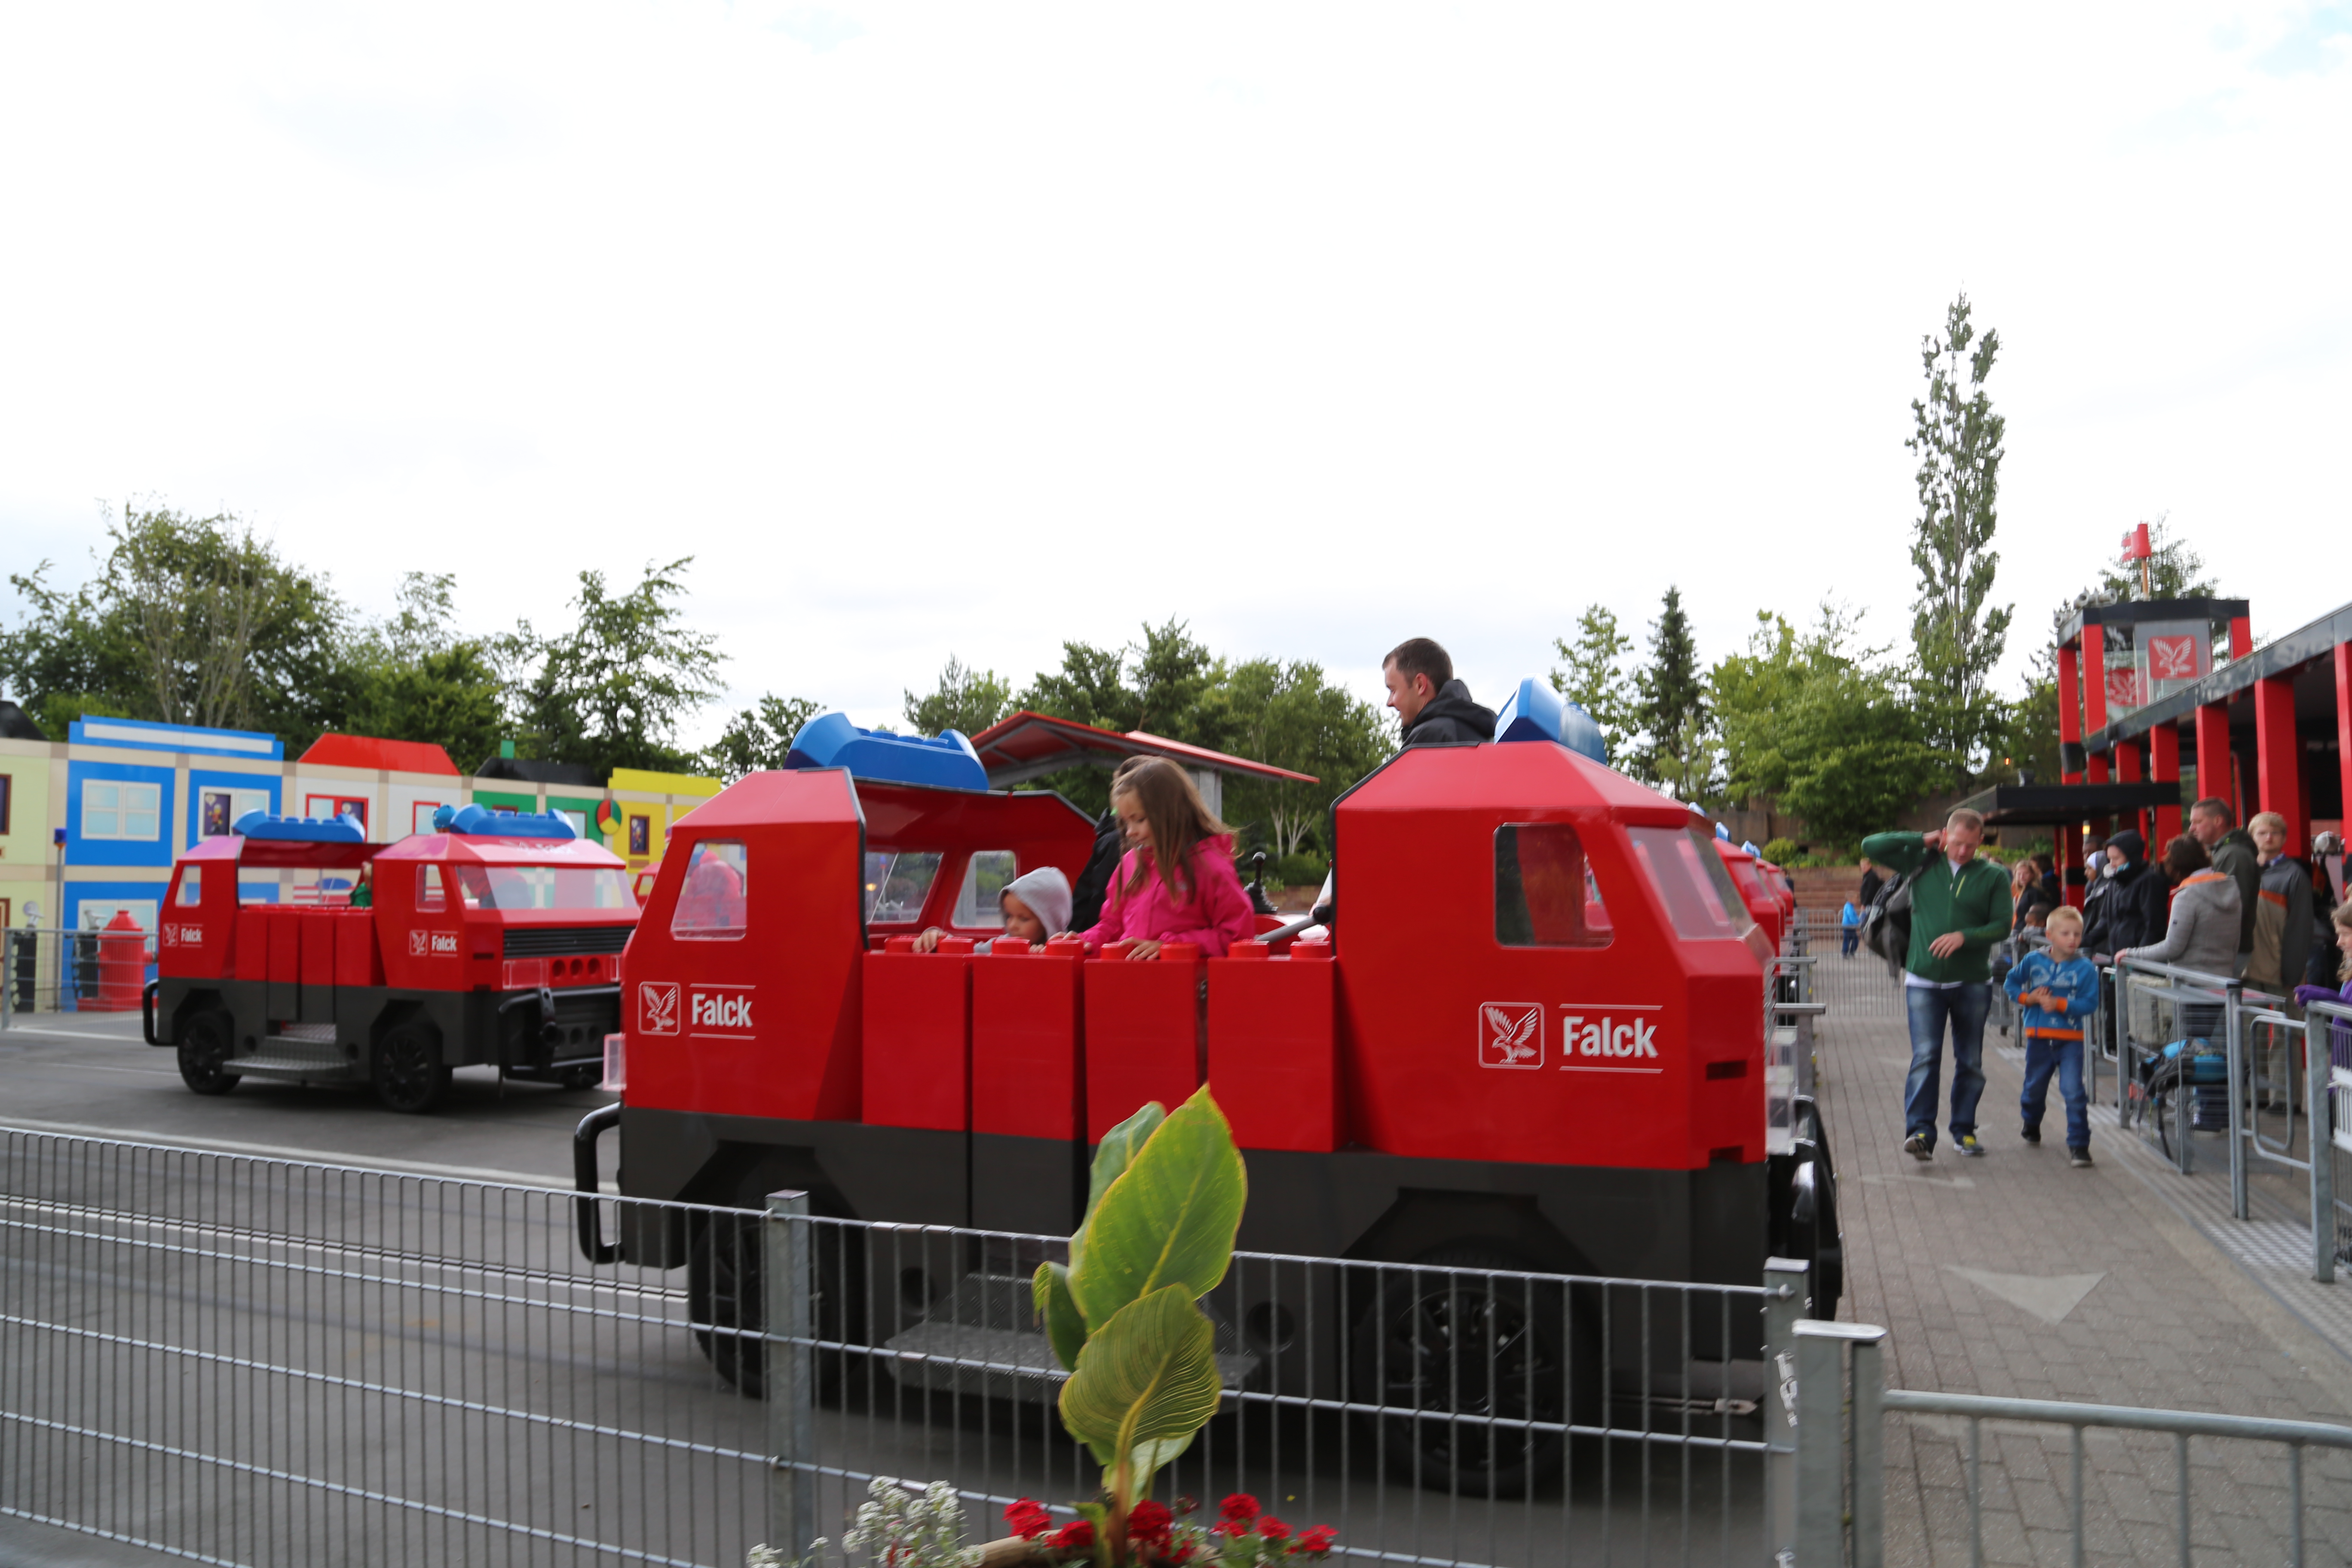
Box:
0, 1131, 1804, 1568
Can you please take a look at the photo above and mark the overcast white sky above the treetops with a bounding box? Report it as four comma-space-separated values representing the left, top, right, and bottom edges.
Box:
0, 0, 2352, 738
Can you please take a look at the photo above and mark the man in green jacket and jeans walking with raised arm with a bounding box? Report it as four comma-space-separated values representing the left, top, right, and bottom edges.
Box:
1863, 808, 2013, 1159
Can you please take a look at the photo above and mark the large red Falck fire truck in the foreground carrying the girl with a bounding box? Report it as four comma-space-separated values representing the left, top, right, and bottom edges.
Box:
576, 682, 1839, 1481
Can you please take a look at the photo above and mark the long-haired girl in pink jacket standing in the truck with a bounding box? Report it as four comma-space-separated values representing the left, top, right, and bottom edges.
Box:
1080, 757, 1259, 962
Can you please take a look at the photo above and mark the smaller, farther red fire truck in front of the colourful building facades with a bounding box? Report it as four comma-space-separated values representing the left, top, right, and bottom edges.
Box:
144, 806, 637, 1112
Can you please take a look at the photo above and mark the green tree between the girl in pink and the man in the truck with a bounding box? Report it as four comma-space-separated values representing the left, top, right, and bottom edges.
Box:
1218, 658, 1397, 861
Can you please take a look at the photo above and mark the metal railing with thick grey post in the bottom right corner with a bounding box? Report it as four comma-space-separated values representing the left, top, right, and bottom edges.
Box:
1792, 1323, 2352, 1568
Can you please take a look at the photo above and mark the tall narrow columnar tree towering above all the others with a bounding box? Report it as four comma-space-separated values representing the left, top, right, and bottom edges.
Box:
1903, 294, 2011, 771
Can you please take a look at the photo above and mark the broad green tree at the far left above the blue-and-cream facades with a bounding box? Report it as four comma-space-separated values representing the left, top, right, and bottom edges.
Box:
0, 505, 353, 750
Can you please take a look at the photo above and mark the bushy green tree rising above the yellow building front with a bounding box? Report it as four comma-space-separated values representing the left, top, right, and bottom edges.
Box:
505, 555, 724, 776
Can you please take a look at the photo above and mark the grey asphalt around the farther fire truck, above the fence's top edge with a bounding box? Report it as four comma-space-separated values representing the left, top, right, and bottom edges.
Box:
0, 1013, 614, 1185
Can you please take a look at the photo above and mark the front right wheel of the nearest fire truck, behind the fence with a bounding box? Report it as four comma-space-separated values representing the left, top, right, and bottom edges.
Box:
1350, 1246, 1602, 1498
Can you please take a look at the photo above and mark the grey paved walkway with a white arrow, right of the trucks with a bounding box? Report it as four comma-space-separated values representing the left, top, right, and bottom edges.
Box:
1818, 952, 2352, 1566
